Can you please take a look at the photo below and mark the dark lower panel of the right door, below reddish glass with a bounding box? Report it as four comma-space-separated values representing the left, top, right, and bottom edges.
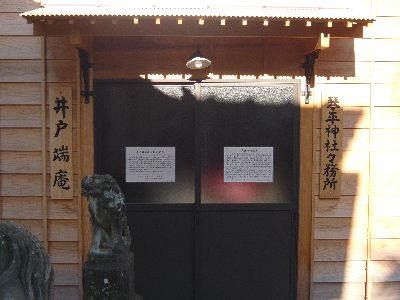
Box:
199, 210, 292, 300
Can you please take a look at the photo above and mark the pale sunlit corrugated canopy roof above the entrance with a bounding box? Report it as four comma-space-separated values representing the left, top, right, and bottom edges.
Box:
22, 6, 373, 22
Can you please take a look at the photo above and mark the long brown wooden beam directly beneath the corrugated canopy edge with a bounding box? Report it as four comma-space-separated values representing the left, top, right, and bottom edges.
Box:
34, 17, 364, 38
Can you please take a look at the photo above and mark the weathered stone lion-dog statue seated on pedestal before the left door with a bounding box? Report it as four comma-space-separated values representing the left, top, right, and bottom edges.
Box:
82, 174, 131, 260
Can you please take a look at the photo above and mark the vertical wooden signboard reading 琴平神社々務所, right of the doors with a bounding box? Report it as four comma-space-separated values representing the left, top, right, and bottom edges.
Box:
319, 97, 343, 198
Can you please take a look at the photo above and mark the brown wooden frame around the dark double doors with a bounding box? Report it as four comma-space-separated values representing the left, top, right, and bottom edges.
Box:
77, 78, 314, 300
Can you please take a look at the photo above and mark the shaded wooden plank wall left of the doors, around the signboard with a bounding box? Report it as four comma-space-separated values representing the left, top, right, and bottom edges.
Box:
0, 0, 81, 299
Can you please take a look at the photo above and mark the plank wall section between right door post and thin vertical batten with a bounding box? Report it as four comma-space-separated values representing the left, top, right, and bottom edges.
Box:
312, 53, 371, 299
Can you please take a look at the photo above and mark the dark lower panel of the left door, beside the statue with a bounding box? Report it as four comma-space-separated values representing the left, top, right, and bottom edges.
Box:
127, 209, 194, 300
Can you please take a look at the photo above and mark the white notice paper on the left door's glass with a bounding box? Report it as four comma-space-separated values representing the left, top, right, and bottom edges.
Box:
126, 147, 175, 182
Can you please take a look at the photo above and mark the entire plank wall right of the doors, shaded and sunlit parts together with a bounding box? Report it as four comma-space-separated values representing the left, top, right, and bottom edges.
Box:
312, 0, 400, 300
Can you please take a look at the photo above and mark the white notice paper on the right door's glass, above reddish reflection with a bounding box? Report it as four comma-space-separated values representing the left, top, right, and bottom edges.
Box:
224, 147, 274, 182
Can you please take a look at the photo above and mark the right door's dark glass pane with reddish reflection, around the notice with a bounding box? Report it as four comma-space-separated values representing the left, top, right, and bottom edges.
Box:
200, 85, 296, 203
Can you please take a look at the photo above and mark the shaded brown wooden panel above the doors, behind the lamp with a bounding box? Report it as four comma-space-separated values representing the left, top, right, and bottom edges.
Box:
94, 37, 355, 79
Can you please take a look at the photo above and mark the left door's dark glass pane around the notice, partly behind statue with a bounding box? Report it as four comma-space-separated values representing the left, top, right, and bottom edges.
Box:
95, 82, 195, 203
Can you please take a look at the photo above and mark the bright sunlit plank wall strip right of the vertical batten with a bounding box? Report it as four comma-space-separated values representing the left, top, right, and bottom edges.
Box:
369, 0, 400, 299
